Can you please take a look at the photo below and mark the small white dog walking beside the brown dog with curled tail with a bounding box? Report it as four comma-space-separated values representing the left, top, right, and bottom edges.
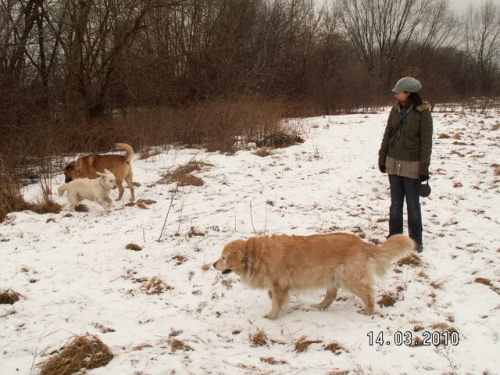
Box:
58, 169, 116, 211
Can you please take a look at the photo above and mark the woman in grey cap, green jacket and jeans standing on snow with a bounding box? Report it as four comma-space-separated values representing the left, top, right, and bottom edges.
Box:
378, 77, 432, 252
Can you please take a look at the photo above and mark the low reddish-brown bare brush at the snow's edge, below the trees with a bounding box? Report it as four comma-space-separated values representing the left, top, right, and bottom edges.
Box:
111, 96, 284, 154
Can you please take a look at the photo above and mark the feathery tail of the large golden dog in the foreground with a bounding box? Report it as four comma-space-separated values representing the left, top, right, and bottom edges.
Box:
372, 234, 415, 277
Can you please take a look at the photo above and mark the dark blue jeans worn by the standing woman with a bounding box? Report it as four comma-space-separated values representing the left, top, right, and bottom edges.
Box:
389, 174, 422, 246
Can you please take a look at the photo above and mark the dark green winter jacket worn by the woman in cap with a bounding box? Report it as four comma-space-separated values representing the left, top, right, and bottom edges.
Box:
378, 102, 432, 175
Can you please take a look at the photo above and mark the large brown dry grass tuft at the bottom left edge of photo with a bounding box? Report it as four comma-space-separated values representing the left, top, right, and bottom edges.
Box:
38, 335, 114, 375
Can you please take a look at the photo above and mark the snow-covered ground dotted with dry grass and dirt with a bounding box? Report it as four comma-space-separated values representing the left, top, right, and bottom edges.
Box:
0, 104, 500, 375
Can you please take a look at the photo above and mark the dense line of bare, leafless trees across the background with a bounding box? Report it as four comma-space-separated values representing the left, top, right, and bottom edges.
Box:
0, 0, 500, 142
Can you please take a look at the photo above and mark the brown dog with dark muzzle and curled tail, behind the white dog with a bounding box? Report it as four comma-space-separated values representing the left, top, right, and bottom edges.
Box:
64, 143, 135, 201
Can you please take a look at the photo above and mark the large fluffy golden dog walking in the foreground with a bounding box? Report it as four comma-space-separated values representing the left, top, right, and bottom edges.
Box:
213, 233, 415, 319
